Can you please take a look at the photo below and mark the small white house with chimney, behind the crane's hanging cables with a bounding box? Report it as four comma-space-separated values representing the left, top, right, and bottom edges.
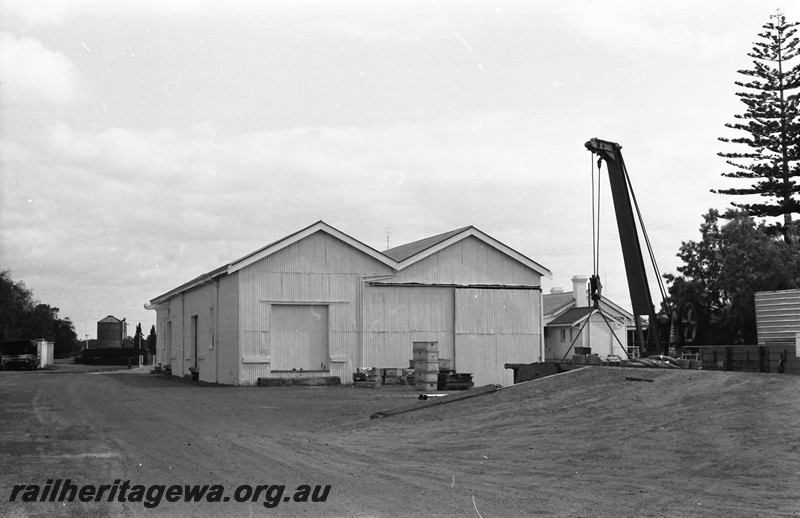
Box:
542, 275, 634, 362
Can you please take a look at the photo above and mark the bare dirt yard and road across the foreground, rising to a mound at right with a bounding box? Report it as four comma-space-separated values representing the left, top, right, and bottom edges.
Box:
0, 367, 800, 518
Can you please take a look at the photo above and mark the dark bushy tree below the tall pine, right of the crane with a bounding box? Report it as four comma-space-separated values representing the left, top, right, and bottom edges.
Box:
664, 209, 800, 344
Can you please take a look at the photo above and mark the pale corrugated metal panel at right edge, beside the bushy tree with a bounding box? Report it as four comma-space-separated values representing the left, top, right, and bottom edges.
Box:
755, 290, 800, 344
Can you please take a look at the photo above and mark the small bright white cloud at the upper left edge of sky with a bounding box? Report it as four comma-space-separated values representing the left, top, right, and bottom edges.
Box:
0, 33, 79, 104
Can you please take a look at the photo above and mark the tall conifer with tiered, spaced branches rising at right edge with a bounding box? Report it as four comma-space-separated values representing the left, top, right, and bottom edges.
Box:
712, 12, 800, 242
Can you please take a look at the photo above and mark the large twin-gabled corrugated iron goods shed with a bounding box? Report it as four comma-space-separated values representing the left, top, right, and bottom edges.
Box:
146, 221, 550, 385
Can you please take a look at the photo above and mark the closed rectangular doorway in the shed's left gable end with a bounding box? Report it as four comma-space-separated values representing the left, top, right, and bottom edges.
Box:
270, 304, 329, 371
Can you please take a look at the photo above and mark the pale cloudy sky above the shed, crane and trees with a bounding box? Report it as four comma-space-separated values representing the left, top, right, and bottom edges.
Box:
0, 0, 800, 339
